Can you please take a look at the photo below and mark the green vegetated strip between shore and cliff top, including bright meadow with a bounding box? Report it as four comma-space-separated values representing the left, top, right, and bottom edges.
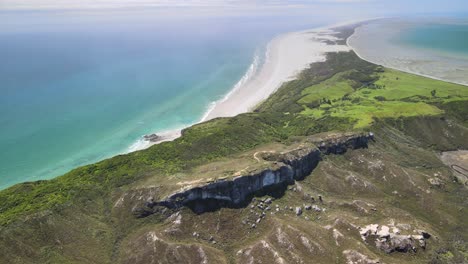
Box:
0, 52, 468, 225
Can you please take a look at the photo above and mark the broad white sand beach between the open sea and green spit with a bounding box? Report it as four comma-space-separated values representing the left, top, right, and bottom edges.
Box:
202, 29, 349, 121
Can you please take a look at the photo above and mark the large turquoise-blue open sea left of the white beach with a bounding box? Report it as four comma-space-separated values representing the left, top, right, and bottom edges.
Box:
0, 11, 321, 189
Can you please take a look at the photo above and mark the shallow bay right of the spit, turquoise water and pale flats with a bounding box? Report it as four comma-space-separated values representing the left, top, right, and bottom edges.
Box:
348, 16, 468, 85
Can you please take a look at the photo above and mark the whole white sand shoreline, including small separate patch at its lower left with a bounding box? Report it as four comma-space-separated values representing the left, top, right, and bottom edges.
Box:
132, 20, 354, 152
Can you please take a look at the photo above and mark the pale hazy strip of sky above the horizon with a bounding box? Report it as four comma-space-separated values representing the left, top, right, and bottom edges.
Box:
0, 0, 468, 16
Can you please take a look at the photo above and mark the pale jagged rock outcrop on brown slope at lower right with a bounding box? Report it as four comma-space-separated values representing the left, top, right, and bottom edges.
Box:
359, 224, 430, 254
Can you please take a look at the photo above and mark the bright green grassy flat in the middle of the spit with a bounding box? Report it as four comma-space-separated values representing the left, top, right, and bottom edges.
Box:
298, 67, 468, 129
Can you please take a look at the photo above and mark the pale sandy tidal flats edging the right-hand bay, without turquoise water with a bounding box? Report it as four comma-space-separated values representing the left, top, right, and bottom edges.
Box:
346, 19, 468, 86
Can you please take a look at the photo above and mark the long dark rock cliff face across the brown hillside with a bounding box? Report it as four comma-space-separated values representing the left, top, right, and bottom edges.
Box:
139, 134, 373, 215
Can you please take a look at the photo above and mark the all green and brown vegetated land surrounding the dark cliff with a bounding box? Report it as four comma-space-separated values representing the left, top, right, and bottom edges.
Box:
0, 48, 468, 263
